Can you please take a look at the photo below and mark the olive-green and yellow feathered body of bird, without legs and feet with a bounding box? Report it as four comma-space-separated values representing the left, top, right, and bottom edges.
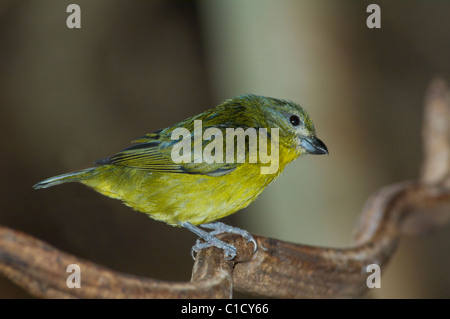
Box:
34, 95, 327, 226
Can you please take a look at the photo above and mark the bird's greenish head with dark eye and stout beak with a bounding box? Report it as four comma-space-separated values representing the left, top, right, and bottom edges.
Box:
224, 94, 328, 159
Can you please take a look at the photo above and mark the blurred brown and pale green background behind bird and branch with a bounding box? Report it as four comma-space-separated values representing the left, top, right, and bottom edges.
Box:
0, 0, 450, 298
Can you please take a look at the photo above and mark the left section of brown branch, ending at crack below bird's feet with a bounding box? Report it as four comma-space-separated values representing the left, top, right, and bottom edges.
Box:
0, 227, 239, 298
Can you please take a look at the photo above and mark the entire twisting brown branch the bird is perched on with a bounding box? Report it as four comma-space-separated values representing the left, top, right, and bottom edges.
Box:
0, 80, 450, 298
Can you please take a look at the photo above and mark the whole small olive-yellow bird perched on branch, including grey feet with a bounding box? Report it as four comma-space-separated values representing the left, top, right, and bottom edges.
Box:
33, 94, 328, 259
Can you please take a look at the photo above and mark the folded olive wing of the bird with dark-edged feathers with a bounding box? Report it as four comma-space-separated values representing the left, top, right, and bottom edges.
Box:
95, 130, 237, 176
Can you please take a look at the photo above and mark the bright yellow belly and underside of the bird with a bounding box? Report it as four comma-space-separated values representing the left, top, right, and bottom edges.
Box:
81, 164, 281, 226
